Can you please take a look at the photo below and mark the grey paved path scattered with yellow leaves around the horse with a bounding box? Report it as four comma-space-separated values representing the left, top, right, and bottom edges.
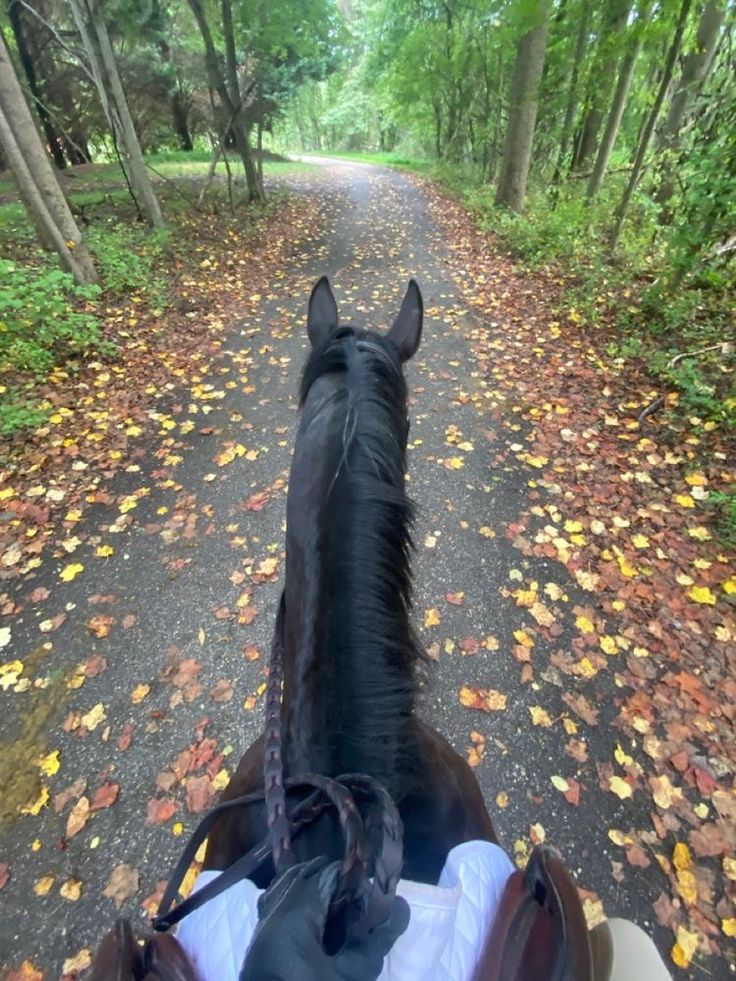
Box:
0, 163, 696, 977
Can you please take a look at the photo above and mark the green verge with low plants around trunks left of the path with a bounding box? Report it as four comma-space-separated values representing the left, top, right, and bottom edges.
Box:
0, 152, 302, 438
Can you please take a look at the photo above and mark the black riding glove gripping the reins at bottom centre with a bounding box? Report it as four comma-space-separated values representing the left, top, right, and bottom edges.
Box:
240, 858, 410, 981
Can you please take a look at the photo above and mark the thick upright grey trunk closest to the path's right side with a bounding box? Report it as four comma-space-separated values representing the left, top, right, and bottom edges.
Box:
496, 0, 549, 213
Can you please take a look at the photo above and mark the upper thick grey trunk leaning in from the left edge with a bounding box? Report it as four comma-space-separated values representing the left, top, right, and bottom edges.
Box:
0, 38, 97, 283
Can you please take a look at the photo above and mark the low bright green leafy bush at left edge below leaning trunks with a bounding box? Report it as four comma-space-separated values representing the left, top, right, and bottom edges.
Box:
0, 259, 99, 374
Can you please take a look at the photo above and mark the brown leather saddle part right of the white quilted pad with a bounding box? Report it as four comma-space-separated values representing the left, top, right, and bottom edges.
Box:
473, 845, 595, 981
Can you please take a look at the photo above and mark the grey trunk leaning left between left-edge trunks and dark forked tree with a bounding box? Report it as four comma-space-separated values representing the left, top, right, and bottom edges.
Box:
70, 0, 164, 228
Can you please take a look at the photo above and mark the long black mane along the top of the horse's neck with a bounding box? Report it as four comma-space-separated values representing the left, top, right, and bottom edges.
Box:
301, 328, 422, 793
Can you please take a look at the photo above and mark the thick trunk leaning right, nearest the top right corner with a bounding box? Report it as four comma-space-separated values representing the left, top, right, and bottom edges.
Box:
654, 0, 726, 213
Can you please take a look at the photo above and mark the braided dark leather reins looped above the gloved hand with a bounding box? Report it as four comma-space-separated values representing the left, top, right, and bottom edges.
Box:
152, 594, 403, 938
